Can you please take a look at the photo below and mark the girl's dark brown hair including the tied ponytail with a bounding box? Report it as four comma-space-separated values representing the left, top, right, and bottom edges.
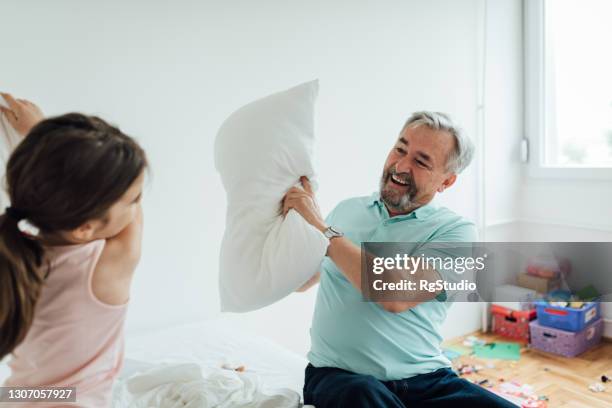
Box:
0, 113, 147, 359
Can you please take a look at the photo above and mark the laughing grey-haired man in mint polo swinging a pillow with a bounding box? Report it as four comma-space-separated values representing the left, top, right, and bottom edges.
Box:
283, 112, 515, 408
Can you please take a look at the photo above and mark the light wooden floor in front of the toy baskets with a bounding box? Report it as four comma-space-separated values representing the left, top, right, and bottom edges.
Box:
445, 332, 612, 408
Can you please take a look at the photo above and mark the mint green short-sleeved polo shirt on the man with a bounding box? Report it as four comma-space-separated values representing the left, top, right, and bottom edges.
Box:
308, 193, 477, 381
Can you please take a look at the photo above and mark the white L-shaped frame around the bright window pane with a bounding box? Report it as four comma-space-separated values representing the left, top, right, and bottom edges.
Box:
523, 0, 612, 181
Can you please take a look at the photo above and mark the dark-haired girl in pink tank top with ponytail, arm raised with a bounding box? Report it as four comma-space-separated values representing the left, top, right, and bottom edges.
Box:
0, 97, 147, 407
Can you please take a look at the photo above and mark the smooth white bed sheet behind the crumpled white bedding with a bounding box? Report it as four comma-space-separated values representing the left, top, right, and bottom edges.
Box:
113, 320, 308, 408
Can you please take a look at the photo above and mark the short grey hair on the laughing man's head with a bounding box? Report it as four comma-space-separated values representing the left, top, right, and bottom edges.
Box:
402, 111, 475, 174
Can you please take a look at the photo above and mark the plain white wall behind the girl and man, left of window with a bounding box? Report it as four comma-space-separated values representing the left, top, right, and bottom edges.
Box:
0, 0, 521, 352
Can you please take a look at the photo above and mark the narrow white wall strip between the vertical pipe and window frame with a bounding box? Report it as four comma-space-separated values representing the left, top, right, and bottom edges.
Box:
483, 0, 523, 231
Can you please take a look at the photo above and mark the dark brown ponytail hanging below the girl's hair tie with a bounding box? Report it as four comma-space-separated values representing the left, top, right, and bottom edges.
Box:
0, 213, 44, 360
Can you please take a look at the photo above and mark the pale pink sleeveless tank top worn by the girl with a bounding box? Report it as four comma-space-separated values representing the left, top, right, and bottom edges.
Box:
6, 240, 127, 407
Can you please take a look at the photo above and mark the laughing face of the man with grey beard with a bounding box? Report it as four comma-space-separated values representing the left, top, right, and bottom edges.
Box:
380, 125, 456, 216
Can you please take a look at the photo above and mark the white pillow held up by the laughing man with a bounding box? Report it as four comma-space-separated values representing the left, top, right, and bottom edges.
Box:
215, 81, 329, 312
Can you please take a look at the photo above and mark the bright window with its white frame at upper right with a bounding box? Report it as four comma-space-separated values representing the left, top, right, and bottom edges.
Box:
524, 0, 612, 178
